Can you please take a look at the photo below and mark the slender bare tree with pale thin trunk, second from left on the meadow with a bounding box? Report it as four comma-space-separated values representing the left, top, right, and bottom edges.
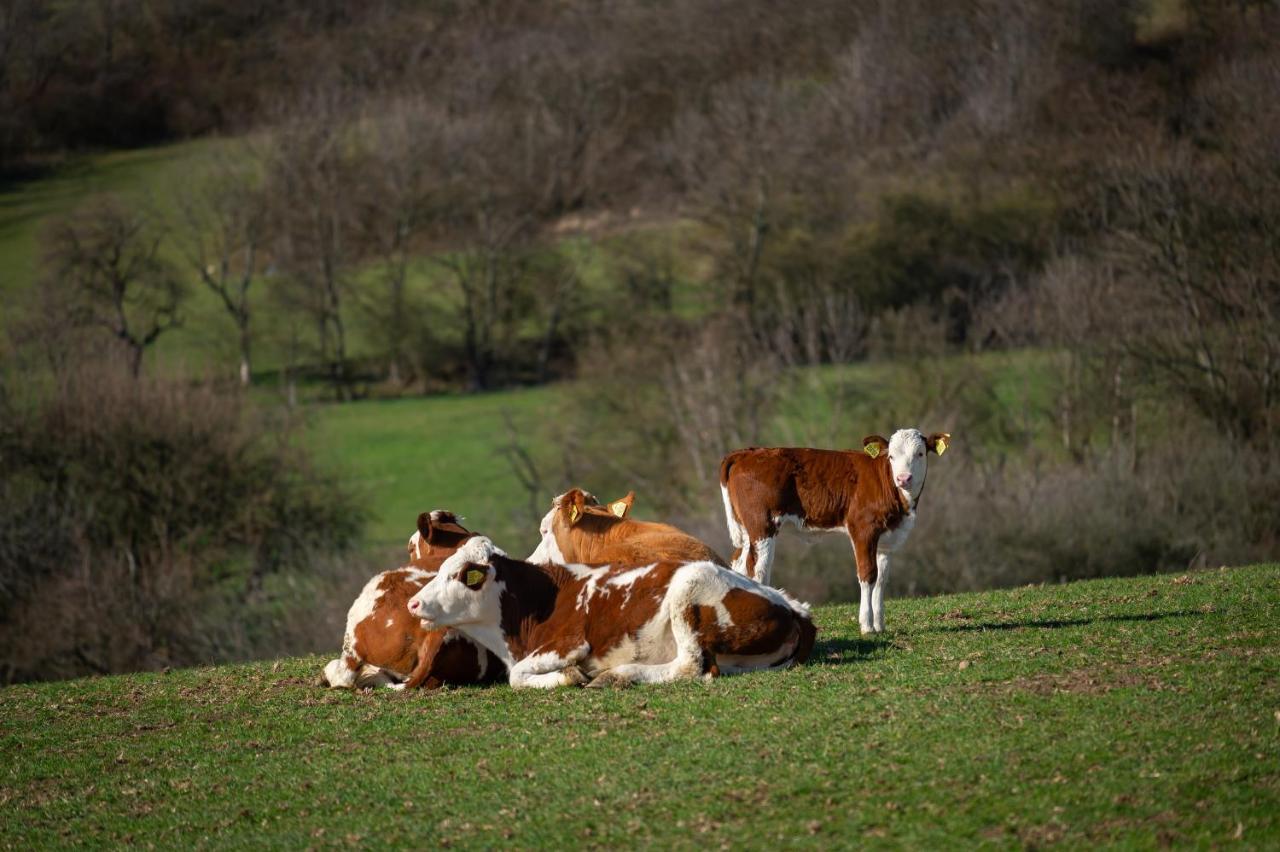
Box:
174, 146, 271, 386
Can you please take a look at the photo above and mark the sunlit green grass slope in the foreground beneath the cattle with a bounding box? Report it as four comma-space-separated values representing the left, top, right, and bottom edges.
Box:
0, 564, 1280, 848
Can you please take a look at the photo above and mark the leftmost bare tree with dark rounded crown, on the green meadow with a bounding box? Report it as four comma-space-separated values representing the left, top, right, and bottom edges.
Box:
44, 196, 186, 376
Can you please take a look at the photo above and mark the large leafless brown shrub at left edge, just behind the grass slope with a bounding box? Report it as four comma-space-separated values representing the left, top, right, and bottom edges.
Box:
0, 355, 360, 681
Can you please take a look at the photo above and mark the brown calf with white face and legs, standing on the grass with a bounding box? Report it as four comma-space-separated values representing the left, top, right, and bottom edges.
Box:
721, 429, 951, 633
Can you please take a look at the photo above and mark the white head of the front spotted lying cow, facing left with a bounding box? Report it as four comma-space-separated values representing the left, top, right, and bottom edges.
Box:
408, 536, 502, 627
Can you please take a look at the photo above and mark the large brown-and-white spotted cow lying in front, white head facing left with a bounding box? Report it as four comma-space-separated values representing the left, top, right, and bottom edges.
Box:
408, 537, 817, 688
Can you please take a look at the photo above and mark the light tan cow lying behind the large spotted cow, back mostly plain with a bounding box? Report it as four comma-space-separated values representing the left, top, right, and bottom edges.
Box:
529, 489, 728, 567
